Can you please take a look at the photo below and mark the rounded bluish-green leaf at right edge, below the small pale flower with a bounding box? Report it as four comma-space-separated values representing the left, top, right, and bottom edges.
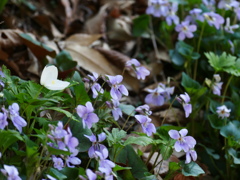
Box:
220, 121, 240, 141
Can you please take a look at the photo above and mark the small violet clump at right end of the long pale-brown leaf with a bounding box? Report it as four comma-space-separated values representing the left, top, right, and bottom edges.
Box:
126, 59, 150, 80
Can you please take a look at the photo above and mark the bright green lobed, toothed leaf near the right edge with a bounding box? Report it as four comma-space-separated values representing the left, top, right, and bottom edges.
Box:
205, 52, 236, 71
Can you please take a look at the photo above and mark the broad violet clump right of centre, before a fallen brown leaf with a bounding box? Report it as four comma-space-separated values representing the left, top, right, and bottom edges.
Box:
145, 83, 174, 106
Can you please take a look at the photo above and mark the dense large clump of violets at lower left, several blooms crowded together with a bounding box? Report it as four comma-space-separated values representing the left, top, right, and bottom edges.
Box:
48, 121, 81, 170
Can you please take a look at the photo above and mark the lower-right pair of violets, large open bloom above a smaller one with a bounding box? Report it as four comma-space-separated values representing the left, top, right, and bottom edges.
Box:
168, 129, 197, 163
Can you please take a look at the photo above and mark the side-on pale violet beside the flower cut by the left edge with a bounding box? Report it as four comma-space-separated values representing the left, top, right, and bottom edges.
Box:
8, 103, 27, 132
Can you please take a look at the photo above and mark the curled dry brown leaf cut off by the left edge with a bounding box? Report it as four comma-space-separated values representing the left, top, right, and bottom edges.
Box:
0, 29, 23, 49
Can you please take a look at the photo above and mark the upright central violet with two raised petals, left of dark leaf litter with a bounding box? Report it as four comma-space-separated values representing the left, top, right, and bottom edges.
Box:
107, 75, 128, 100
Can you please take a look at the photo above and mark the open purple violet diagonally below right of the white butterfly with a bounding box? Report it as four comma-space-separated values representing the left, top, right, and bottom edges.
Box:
76, 102, 99, 129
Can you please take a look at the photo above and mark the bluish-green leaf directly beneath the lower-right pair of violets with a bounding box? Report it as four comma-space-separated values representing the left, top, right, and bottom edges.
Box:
181, 161, 205, 177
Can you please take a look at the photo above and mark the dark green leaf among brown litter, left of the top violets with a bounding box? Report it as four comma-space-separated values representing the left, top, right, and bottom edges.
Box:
133, 14, 150, 37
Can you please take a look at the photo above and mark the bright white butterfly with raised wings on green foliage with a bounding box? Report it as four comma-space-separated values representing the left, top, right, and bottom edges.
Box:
40, 66, 70, 90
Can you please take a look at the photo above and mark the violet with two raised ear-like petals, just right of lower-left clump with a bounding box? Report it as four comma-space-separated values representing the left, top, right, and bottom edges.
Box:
84, 132, 108, 159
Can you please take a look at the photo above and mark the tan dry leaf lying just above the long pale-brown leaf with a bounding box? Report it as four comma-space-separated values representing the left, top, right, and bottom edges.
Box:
65, 34, 102, 46
